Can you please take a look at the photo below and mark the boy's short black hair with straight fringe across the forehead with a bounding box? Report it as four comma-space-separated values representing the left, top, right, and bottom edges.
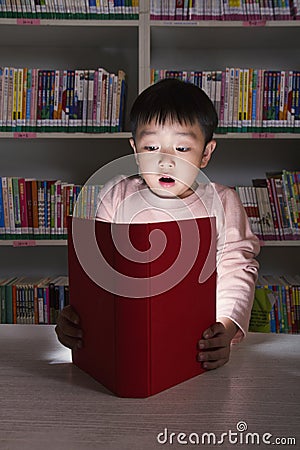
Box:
130, 78, 218, 144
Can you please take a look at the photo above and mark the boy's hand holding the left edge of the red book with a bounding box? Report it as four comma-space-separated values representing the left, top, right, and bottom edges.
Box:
55, 305, 83, 350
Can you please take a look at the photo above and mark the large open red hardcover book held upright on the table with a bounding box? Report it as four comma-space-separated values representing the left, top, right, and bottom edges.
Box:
68, 218, 216, 398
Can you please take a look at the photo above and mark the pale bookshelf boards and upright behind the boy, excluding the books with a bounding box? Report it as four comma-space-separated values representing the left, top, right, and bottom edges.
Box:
0, 0, 300, 302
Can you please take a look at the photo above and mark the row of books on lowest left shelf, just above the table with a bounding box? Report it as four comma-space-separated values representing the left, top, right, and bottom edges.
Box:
0, 276, 69, 325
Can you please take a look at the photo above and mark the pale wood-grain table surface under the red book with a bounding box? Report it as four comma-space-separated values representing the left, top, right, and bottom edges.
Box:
0, 325, 300, 450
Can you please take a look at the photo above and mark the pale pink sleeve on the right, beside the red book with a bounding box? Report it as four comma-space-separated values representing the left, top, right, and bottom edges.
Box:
217, 189, 260, 342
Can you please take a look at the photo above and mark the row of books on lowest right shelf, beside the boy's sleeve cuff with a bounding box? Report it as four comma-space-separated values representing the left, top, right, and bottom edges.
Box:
249, 275, 300, 334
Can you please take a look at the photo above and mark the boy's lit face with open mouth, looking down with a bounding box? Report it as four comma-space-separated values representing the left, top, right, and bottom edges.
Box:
130, 120, 216, 198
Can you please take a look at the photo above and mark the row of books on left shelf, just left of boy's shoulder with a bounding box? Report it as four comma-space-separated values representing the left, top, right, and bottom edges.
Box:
0, 177, 101, 241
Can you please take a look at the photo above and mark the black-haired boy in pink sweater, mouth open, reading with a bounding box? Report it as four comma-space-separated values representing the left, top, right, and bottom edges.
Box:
56, 79, 259, 369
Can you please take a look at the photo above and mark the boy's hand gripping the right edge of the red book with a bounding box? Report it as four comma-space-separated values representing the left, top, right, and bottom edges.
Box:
197, 319, 238, 370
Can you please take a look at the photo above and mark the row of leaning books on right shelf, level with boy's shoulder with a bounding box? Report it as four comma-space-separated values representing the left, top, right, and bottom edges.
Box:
235, 170, 300, 241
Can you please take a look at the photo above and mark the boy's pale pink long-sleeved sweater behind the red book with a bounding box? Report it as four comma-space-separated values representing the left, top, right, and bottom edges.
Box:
97, 176, 259, 342
